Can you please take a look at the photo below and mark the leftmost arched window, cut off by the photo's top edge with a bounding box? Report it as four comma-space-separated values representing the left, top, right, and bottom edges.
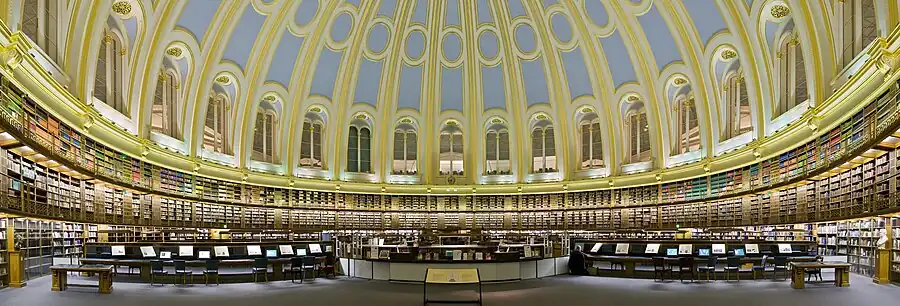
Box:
21, 0, 65, 66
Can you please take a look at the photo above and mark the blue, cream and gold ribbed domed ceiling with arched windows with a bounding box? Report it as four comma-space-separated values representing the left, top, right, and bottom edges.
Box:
17, 0, 876, 184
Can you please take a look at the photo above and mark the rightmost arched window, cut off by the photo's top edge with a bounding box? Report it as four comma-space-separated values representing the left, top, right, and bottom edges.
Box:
838, 0, 878, 67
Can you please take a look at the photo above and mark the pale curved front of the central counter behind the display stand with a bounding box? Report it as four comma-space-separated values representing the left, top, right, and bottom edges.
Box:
339, 257, 569, 282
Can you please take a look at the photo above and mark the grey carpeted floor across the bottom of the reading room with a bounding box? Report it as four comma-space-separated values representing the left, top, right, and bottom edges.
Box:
0, 274, 900, 306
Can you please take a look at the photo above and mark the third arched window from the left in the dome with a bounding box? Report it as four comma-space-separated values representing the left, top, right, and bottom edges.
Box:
150, 72, 181, 138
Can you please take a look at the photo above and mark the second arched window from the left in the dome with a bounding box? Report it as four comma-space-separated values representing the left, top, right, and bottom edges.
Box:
94, 28, 129, 116
